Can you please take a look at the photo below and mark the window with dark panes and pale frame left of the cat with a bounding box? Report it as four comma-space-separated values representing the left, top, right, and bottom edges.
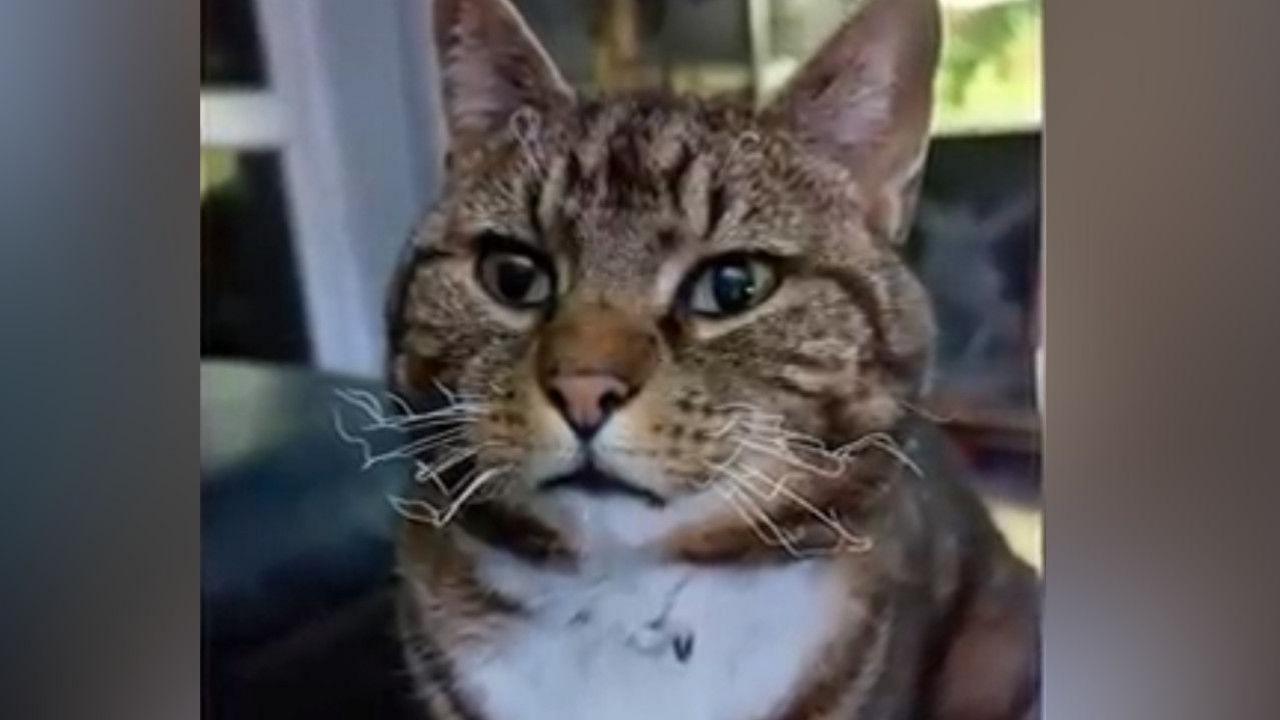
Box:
200, 0, 439, 377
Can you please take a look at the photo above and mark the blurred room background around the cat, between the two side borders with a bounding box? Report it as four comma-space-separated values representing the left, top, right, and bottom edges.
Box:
200, 0, 1042, 717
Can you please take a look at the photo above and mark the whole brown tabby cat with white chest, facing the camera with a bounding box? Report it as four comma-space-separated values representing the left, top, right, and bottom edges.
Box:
388, 0, 1039, 720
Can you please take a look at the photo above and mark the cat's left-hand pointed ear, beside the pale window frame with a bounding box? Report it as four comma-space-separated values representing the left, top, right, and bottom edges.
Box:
434, 0, 573, 142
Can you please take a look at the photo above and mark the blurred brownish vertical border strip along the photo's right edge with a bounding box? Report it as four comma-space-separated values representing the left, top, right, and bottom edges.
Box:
1044, 0, 1280, 719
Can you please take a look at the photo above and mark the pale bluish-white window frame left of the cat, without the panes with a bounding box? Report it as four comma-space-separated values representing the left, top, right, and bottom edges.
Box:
200, 0, 440, 377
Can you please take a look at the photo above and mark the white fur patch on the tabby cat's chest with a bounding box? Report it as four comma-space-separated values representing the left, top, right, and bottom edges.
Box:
454, 545, 859, 720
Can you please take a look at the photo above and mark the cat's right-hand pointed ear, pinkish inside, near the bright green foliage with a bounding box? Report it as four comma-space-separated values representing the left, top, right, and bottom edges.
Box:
764, 0, 941, 240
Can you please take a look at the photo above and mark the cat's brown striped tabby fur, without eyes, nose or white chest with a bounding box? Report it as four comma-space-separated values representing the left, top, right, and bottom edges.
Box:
389, 0, 1038, 720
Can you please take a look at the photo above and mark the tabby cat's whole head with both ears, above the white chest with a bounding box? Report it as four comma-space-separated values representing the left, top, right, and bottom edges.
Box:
392, 0, 937, 527
